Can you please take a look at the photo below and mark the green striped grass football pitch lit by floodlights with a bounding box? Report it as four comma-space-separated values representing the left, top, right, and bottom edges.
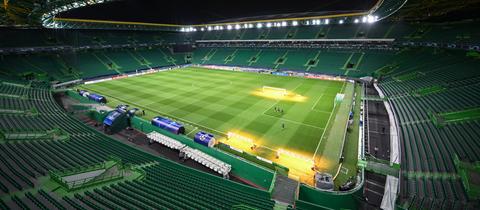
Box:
82, 67, 353, 182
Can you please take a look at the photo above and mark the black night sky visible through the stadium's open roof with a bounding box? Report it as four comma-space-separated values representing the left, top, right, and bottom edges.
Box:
60, 0, 377, 24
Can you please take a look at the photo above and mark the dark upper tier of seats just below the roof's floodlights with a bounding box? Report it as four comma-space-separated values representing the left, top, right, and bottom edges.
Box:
0, 22, 480, 48
